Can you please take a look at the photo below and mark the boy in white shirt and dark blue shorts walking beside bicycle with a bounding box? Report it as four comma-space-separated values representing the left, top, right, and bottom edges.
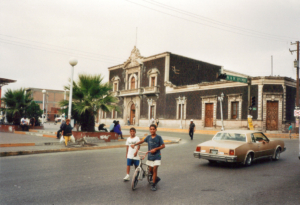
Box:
124, 127, 140, 181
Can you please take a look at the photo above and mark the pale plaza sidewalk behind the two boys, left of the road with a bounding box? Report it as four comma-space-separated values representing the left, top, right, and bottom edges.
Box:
0, 125, 180, 157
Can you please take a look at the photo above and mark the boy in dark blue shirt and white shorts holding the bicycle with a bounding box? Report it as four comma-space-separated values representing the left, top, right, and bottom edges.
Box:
131, 124, 165, 191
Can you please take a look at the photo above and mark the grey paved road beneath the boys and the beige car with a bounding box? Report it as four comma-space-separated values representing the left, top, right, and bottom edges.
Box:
0, 133, 300, 204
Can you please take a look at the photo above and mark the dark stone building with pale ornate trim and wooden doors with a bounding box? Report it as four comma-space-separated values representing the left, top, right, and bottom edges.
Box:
99, 47, 296, 131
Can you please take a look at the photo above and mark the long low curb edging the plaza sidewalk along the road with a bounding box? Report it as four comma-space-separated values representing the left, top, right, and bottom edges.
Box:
0, 139, 181, 157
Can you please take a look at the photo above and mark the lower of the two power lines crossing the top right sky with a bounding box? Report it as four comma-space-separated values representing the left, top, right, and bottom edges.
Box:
125, 0, 287, 43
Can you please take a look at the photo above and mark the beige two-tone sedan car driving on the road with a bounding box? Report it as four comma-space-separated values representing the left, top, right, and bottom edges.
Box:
194, 130, 286, 166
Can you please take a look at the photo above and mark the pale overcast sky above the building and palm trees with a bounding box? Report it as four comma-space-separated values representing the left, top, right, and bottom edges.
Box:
0, 0, 300, 97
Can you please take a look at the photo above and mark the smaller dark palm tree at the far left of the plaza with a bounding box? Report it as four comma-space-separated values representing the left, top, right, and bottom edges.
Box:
1, 88, 33, 125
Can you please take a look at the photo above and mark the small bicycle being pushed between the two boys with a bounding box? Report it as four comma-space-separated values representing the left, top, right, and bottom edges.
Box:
131, 151, 152, 190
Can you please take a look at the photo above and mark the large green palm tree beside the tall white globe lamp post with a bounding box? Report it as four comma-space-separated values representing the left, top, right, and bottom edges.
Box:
60, 74, 119, 132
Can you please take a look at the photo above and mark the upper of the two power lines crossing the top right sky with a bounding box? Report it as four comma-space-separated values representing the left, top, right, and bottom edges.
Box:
143, 0, 294, 39
